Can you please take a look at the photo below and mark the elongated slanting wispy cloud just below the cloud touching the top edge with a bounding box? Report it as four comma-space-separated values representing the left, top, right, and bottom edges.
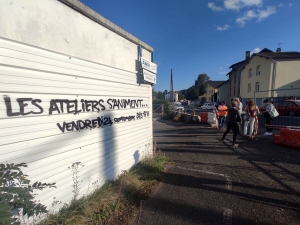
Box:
236, 6, 276, 26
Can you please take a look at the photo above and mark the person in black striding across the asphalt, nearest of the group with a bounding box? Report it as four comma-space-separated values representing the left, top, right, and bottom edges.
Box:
221, 101, 242, 147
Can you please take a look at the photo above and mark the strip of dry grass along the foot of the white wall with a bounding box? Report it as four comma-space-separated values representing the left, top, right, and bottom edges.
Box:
40, 154, 168, 225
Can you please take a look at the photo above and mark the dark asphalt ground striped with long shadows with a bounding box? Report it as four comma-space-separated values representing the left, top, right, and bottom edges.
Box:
132, 120, 300, 225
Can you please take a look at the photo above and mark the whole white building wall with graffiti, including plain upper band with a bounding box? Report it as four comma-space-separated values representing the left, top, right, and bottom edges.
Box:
0, 0, 153, 218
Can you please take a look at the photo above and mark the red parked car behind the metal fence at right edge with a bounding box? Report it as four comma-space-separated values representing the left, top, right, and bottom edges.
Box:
260, 100, 300, 116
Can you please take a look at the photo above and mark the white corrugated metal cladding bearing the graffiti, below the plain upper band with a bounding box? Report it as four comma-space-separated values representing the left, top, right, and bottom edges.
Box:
0, 39, 152, 211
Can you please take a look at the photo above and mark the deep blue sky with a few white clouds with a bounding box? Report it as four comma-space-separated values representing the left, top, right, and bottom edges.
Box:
80, 0, 300, 91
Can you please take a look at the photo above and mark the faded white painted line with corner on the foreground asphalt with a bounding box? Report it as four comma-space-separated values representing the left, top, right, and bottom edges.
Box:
176, 166, 232, 225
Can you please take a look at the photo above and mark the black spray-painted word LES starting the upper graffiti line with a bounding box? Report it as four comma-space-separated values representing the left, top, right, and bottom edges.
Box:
4, 96, 44, 116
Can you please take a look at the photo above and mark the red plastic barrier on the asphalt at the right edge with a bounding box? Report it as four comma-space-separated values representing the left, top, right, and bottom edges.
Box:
273, 128, 300, 149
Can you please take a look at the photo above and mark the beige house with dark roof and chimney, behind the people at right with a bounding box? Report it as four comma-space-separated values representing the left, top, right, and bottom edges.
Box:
240, 48, 300, 106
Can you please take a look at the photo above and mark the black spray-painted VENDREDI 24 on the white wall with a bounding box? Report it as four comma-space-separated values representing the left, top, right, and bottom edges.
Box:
56, 116, 113, 133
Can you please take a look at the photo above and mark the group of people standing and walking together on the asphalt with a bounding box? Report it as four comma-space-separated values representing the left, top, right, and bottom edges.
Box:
217, 98, 274, 146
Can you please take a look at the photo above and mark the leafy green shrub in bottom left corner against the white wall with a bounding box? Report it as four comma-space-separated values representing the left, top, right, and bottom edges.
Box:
0, 163, 55, 224
